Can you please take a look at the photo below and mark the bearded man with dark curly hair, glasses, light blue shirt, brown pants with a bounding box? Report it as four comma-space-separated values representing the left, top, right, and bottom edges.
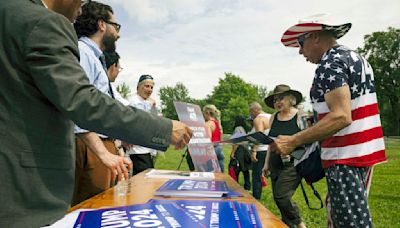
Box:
72, 1, 132, 206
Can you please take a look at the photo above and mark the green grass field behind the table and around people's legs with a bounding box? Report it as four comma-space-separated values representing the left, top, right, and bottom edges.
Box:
155, 139, 400, 228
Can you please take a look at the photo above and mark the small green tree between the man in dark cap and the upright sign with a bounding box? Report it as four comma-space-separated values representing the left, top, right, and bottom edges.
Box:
159, 82, 193, 120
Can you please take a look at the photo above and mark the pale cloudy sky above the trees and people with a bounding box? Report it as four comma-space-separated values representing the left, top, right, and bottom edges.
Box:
101, 0, 400, 109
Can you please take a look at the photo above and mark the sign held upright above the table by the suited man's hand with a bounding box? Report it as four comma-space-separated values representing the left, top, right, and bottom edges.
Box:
174, 102, 221, 172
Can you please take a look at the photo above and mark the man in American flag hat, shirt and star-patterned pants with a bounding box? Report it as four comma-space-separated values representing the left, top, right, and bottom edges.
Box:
271, 15, 386, 227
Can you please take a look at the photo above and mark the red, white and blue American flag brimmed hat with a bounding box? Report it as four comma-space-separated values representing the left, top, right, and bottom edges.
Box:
281, 14, 351, 47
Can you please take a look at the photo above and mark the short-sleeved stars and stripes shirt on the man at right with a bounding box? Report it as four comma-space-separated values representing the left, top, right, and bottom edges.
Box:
310, 46, 386, 168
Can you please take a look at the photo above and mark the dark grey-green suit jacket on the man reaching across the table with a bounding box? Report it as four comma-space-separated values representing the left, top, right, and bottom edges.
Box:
0, 0, 172, 227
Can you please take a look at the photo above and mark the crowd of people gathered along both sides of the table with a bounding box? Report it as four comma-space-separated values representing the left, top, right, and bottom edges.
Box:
0, 0, 386, 227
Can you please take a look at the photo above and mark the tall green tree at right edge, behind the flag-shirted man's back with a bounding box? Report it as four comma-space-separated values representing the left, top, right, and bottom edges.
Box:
358, 28, 400, 135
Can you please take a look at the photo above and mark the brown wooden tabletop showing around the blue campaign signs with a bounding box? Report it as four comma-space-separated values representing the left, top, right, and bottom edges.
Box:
69, 171, 287, 227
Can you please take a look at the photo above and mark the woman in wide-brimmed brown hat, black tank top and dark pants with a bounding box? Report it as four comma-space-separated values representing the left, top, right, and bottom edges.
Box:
263, 85, 305, 227
